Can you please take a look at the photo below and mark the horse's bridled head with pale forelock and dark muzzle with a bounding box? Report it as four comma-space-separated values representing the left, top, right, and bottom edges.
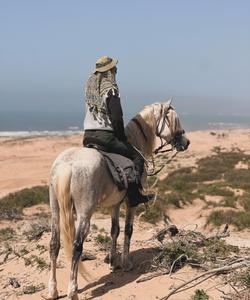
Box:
155, 100, 190, 151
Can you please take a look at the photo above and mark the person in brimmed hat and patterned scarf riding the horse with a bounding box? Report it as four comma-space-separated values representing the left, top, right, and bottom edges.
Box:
83, 56, 153, 206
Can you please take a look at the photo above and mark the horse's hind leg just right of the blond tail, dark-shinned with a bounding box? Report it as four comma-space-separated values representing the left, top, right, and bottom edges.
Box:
68, 215, 90, 300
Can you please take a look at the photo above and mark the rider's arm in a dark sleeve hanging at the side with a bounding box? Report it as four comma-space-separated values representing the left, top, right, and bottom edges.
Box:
106, 89, 127, 141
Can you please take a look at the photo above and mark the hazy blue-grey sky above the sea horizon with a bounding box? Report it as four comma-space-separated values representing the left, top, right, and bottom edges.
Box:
0, 0, 250, 115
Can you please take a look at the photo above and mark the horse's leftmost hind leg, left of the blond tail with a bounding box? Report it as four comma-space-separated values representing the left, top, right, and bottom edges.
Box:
48, 186, 60, 299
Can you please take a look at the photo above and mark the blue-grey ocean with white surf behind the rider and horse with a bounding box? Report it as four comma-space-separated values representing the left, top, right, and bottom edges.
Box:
0, 111, 250, 137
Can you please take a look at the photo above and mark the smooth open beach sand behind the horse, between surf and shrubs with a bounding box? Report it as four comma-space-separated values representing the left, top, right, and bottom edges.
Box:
0, 129, 250, 197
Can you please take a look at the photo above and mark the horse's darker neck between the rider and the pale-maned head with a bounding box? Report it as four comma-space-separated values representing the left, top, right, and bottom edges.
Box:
126, 113, 155, 157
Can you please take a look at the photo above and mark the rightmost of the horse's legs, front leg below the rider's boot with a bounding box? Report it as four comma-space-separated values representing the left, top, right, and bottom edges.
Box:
122, 202, 136, 271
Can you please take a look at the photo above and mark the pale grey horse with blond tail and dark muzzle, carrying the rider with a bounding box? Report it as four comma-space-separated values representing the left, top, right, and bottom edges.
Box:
48, 101, 189, 300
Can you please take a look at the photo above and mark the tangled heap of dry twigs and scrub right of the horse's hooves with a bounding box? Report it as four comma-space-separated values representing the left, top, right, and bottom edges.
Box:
153, 225, 239, 273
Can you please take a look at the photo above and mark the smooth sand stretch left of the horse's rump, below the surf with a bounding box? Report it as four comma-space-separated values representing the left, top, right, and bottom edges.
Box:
0, 135, 82, 197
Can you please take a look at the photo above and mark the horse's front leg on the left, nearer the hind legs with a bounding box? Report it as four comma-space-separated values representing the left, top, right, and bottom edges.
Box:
109, 203, 121, 270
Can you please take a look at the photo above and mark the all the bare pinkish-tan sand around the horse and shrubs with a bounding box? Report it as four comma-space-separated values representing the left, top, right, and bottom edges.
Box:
0, 129, 250, 300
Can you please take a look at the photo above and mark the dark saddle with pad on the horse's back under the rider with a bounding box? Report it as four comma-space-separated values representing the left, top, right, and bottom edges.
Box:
85, 144, 140, 191
